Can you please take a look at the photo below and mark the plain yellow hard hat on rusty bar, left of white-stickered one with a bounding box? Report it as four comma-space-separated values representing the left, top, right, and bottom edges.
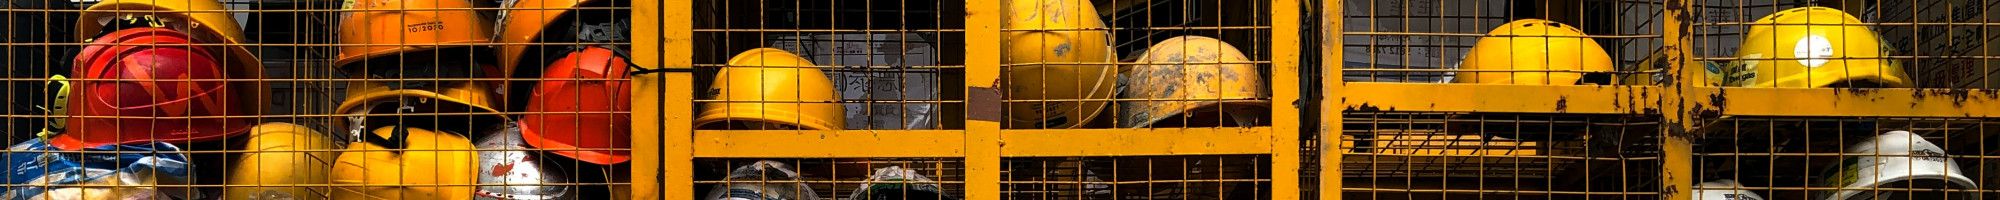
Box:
1454, 18, 1614, 86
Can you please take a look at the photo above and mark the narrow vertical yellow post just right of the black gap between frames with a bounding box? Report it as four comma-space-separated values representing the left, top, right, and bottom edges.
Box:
1316, 0, 1348, 200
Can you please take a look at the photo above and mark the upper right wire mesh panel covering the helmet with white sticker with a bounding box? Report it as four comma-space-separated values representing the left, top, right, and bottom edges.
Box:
1690, 0, 2000, 88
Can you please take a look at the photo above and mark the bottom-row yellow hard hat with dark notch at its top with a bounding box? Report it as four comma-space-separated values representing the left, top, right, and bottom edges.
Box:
332, 126, 478, 200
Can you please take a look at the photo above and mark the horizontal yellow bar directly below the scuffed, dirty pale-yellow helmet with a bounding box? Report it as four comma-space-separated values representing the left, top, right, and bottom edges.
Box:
1000, 128, 1298, 156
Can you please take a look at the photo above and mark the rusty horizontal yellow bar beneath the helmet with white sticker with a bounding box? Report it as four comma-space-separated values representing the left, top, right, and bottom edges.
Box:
1708, 88, 2000, 118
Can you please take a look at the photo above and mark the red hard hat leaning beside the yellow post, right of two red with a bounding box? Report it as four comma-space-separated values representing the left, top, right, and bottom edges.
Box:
520, 46, 632, 164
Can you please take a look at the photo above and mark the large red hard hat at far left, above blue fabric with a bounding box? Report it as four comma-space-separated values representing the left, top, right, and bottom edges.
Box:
61, 28, 254, 150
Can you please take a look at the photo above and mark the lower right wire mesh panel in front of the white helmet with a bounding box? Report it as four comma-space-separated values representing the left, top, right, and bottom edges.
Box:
1694, 118, 2000, 200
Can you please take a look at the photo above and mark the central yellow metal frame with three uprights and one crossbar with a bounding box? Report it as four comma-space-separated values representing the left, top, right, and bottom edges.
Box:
632, 0, 1302, 200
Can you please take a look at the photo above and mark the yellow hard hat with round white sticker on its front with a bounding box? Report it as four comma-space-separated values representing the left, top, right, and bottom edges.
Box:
1730, 6, 1910, 88
